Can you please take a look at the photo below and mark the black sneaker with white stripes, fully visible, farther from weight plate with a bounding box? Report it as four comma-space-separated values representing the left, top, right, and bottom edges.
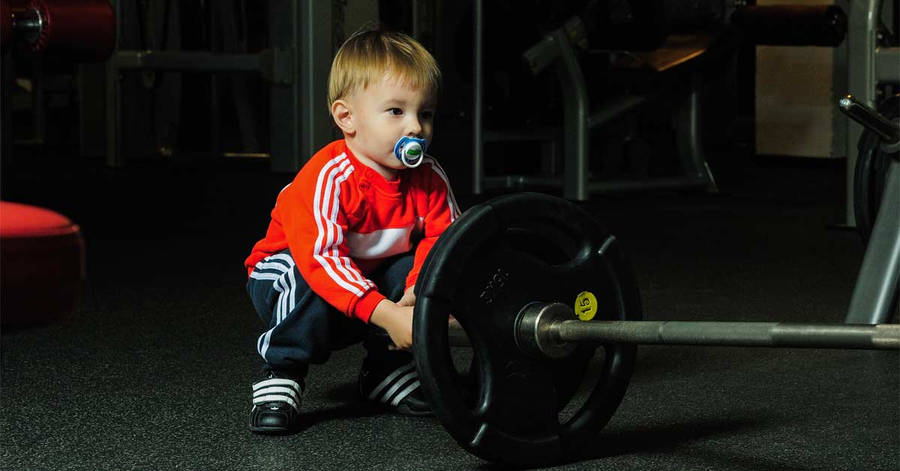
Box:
250, 370, 304, 434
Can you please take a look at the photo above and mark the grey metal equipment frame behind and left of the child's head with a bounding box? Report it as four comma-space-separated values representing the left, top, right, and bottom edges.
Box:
105, 0, 332, 172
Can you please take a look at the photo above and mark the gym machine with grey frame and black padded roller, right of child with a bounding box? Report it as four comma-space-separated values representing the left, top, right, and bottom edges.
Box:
473, 0, 890, 200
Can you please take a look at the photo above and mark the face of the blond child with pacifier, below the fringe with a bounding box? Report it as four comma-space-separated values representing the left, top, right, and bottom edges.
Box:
348, 76, 435, 174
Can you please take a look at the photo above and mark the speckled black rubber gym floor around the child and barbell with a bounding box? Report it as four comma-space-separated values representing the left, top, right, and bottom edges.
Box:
0, 148, 900, 471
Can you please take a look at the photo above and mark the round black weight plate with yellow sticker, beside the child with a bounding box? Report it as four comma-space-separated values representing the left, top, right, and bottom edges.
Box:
413, 193, 641, 465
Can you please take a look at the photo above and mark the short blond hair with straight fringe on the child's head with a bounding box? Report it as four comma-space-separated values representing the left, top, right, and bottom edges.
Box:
328, 30, 441, 106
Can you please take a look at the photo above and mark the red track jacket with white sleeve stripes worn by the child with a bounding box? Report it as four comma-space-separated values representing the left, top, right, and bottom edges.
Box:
244, 140, 459, 322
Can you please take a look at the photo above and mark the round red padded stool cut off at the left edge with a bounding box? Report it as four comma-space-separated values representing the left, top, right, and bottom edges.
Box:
0, 201, 85, 325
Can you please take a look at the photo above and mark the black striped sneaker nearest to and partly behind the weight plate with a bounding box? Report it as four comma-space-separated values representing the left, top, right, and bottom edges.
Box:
359, 352, 433, 417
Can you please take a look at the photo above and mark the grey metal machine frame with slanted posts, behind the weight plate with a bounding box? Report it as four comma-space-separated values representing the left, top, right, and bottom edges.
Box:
472, 0, 716, 201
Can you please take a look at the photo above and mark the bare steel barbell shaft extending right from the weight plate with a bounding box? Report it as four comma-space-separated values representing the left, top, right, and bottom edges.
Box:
549, 320, 900, 350
